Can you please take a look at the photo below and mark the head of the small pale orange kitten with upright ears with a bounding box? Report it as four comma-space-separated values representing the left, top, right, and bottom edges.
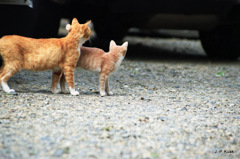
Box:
109, 40, 128, 56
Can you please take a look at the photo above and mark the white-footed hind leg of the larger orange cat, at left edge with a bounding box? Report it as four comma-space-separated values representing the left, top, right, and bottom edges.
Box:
0, 64, 19, 93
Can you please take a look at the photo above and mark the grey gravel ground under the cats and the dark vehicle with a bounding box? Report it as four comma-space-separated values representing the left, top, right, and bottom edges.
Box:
0, 37, 240, 159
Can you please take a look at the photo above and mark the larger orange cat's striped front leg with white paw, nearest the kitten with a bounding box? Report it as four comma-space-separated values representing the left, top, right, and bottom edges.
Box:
64, 67, 79, 95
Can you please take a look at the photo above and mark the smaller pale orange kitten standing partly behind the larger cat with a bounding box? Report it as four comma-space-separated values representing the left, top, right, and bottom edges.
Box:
55, 25, 128, 96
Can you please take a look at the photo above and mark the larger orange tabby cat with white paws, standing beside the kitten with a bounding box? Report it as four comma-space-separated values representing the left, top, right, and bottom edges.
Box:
0, 18, 91, 95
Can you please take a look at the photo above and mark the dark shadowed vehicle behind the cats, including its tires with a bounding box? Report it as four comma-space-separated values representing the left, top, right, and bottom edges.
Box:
0, 0, 240, 58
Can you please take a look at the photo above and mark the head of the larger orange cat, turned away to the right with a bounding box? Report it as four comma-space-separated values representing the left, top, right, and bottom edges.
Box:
66, 18, 91, 41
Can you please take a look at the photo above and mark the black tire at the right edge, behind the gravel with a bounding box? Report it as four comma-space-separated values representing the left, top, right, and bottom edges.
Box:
200, 25, 240, 59
